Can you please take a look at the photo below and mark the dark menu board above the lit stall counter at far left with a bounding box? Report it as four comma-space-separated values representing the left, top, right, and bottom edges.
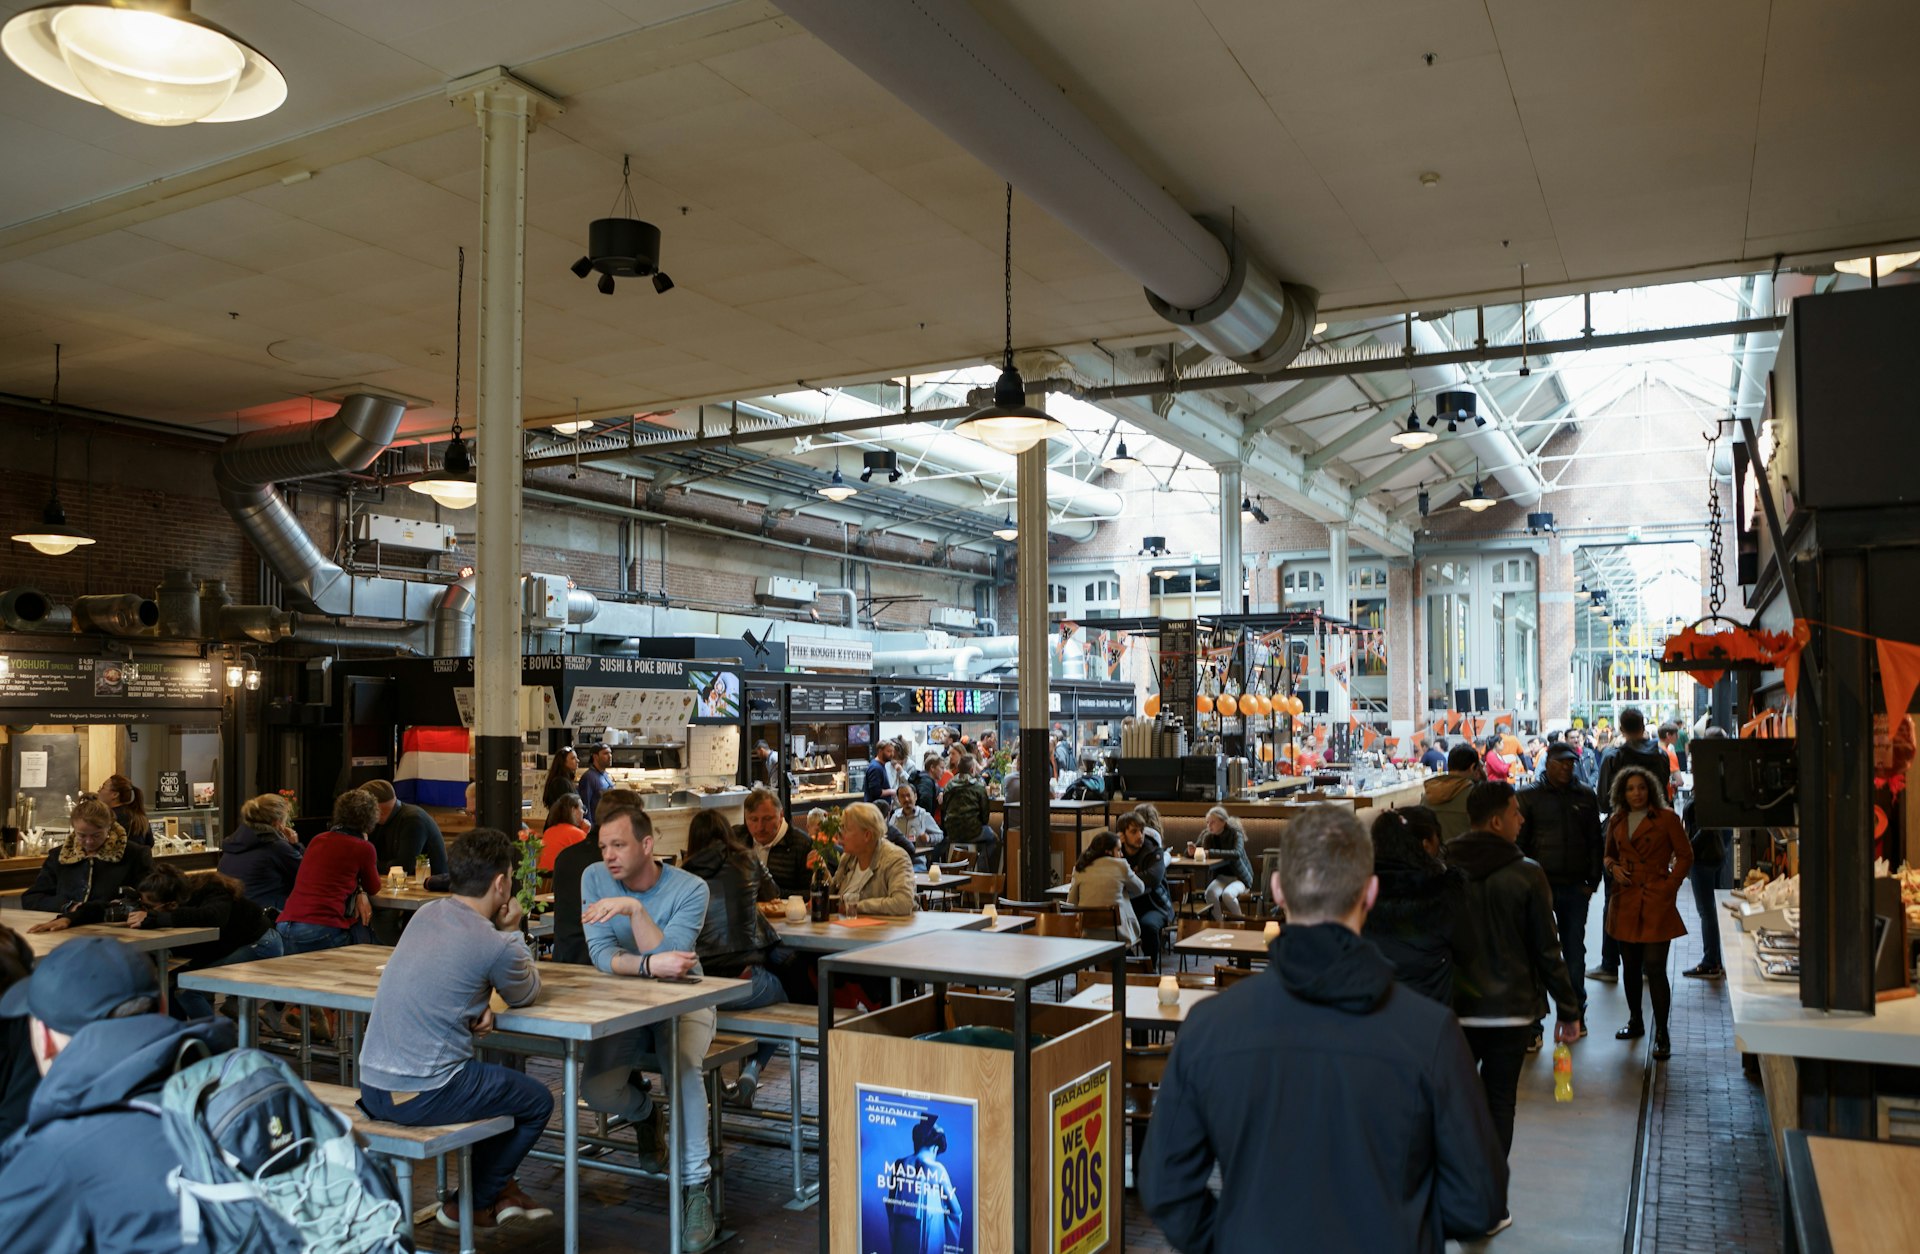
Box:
0, 653, 221, 722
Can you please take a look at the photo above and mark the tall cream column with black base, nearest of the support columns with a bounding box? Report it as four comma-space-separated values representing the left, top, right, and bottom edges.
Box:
447, 69, 574, 829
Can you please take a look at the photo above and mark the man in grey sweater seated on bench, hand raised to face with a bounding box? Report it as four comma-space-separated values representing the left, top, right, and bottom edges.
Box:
361, 828, 553, 1229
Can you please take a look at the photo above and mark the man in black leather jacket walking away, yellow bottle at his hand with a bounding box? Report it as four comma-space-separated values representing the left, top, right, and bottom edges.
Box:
1446, 784, 1580, 1154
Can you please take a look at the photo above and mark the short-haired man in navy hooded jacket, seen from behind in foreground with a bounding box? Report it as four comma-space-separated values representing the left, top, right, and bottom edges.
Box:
1139, 807, 1507, 1254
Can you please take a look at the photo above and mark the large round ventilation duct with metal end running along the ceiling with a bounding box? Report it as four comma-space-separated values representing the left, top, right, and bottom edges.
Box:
780, 0, 1319, 371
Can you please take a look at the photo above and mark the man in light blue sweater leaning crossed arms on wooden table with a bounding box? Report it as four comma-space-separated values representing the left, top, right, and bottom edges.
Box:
580, 791, 714, 1250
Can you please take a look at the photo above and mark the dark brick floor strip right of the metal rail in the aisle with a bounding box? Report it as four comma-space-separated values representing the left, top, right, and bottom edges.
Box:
1640, 887, 1782, 1254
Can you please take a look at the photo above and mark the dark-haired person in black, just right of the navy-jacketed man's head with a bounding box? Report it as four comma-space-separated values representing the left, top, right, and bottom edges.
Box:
1361, 805, 1467, 1008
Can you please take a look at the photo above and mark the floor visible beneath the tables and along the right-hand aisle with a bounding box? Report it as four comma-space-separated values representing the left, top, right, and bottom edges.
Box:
353, 904, 1780, 1254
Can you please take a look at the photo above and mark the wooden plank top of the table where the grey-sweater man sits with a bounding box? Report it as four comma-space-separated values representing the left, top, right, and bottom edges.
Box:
180, 945, 751, 1041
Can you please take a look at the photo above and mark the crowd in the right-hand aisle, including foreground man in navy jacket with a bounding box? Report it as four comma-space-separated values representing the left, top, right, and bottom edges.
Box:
1123, 709, 1724, 1250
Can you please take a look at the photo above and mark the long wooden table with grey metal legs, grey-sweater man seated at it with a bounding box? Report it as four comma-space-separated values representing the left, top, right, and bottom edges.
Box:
180, 945, 751, 1254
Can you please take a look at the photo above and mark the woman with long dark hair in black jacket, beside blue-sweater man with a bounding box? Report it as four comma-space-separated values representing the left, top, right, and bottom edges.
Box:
684, 810, 812, 1106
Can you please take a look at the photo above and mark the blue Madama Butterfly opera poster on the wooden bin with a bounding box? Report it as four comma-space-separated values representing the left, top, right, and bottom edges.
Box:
854, 1085, 979, 1254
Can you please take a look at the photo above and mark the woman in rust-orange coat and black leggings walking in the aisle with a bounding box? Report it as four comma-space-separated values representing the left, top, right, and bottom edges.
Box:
1607, 766, 1693, 1058
